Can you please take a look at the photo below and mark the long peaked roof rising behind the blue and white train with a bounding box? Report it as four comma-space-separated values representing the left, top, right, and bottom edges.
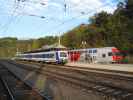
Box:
24, 44, 67, 54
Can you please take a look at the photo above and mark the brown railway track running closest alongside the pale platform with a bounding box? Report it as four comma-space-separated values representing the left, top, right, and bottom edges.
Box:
15, 61, 133, 80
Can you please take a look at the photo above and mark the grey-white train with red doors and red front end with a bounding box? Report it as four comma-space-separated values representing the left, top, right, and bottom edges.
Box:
68, 47, 124, 63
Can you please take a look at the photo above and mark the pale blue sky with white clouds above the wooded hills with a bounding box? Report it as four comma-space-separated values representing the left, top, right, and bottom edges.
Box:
0, 0, 118, 39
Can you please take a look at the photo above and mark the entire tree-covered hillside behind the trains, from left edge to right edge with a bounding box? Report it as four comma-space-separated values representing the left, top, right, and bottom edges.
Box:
0, 0, 133, 57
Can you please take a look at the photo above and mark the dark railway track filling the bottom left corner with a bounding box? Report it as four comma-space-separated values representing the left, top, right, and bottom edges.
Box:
0, 64, 46, 100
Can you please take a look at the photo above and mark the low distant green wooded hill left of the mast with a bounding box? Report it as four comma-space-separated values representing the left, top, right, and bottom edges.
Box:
0, 36, 58, 58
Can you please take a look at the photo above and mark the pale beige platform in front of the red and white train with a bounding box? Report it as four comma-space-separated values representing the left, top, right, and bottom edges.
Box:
66, 62, 133, 73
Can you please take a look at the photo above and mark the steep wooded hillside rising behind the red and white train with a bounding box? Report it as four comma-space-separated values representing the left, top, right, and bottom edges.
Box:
62, 0, 133, 52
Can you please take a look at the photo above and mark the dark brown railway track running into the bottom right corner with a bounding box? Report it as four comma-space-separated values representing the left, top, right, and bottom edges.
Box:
41, 71, 133, 100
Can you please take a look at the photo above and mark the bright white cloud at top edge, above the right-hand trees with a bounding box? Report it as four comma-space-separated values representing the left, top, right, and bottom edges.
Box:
68, 0, 114, 13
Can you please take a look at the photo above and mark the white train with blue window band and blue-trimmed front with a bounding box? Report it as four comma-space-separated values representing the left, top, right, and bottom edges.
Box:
17, 50, 68, 64
